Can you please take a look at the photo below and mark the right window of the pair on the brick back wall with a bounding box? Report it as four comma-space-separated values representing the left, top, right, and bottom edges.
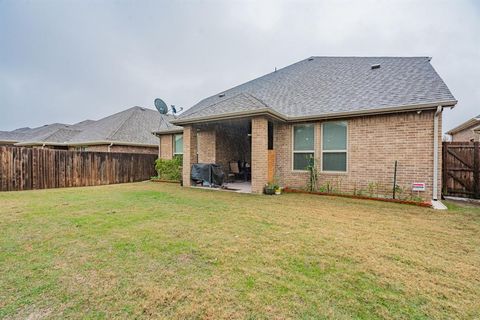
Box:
322, 121, 347, 172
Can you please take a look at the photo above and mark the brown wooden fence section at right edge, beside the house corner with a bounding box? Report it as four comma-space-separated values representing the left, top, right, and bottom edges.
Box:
442, 142, 480, 199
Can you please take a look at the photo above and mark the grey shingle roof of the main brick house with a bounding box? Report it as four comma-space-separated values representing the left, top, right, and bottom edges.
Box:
173, 57, 457, 124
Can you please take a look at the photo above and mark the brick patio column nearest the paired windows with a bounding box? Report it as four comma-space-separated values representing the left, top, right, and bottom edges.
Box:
252, 117, 268, 193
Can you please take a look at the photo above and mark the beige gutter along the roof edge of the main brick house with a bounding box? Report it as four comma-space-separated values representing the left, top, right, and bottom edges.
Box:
170, 100, 458, 125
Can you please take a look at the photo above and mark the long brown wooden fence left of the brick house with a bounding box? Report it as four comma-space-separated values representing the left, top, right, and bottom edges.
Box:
0, 147, 157, 191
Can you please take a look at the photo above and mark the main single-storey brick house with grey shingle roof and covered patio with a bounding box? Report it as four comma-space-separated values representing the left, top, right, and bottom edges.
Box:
158, 57, 457, 199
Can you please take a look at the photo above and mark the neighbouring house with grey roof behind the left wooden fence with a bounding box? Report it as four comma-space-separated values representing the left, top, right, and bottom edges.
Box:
9, 107, 170, 154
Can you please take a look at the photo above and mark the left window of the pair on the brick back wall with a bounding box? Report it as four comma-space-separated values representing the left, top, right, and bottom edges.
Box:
293, 124, 315, 170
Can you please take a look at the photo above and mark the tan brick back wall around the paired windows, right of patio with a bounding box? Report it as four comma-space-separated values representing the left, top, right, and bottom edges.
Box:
274, 111, 442, 200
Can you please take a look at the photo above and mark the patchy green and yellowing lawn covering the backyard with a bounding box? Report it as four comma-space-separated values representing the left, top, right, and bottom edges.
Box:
0, 183, 480, 319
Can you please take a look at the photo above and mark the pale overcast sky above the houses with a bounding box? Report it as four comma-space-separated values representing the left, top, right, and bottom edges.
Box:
0, 0, 480, 130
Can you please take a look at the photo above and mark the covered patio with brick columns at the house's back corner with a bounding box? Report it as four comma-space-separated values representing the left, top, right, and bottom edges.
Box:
183, 116, 275, 193
